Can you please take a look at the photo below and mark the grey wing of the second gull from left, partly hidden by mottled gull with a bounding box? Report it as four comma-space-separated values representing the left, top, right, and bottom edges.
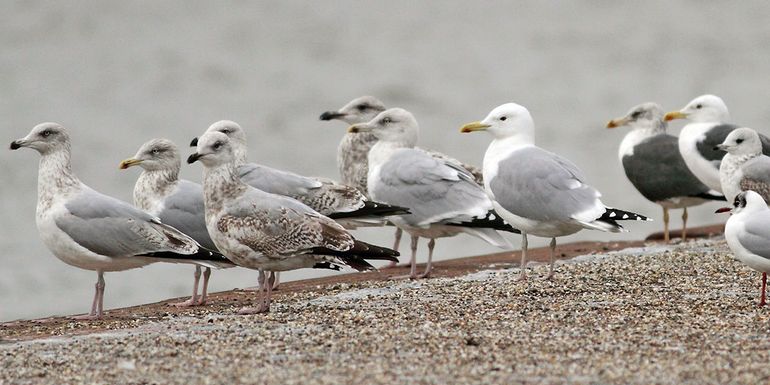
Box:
158, 180, 217, 251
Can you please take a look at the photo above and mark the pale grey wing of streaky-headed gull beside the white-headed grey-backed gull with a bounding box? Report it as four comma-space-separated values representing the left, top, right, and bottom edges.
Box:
370, 149, 492, 226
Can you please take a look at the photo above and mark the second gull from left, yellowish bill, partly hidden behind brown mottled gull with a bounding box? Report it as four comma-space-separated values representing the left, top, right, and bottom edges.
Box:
120, 139, 234, 306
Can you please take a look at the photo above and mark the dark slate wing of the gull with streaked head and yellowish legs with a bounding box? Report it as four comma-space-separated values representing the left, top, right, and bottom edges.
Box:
623, 134, 709, 202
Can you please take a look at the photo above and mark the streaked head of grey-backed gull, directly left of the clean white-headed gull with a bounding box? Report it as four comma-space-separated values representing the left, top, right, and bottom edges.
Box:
348, 108, 420, 147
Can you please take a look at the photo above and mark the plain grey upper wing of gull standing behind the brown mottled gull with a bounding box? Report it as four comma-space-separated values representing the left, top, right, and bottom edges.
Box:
238, 163, 322, 196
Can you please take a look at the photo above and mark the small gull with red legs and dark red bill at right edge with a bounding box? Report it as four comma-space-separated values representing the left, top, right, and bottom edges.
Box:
717, 190, 770, 306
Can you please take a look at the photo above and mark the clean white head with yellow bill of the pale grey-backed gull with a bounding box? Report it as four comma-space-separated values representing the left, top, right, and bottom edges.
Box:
460, 103, 535, 143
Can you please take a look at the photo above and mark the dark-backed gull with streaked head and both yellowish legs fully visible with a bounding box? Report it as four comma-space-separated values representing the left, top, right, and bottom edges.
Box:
607, 103, 725, 242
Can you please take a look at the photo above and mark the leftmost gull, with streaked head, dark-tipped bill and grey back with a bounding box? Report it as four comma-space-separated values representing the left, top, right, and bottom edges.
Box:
11, 123, 229, 319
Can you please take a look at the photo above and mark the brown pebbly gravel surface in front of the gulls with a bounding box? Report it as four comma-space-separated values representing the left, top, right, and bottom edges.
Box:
0, 240, 770, 384
